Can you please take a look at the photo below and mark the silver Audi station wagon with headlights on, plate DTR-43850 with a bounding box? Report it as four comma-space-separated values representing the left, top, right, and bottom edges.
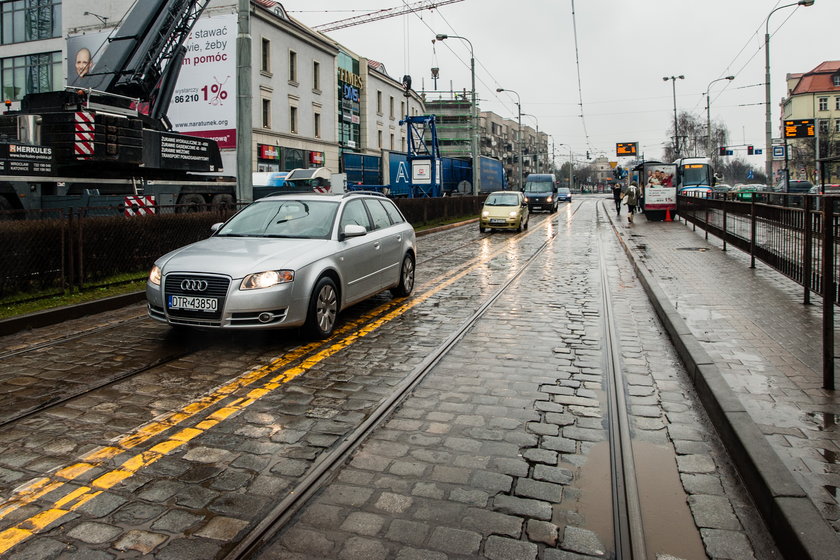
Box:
146, 192, 415, 338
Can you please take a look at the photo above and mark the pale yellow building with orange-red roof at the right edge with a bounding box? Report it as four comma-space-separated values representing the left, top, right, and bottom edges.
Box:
776, 60, 840, 183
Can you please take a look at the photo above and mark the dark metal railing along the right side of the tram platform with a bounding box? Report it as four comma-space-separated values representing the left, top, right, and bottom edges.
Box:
677, 192, 840, 390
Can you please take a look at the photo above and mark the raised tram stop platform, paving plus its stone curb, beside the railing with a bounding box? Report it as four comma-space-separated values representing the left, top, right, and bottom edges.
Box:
604, 205, 840, 558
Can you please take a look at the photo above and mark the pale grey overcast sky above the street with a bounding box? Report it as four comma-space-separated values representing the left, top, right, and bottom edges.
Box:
282, 0, 840, 168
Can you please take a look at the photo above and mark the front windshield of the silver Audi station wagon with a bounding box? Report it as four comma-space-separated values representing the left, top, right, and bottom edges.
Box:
216, 198, 338, 239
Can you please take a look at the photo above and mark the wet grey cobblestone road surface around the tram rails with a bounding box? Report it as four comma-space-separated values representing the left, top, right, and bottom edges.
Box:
0, 198, 777, 560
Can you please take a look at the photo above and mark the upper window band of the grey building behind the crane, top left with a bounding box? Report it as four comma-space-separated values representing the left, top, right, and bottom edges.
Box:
0, 0, 61, 45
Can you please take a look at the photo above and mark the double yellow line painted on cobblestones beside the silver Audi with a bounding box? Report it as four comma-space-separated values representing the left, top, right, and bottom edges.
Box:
0, 215, 550, 554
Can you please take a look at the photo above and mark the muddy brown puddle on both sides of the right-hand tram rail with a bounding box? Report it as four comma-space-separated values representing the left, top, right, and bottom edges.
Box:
577, 441, 707, 560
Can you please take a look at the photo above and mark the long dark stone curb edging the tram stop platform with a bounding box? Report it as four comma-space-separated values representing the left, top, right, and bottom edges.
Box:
606, 207, 838, 560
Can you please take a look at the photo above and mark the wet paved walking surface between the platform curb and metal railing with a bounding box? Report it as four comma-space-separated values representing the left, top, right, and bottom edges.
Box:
608, 209, 840, 554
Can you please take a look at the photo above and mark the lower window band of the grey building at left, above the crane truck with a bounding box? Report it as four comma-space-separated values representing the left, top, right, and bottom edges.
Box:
0, 51, 63, 101
